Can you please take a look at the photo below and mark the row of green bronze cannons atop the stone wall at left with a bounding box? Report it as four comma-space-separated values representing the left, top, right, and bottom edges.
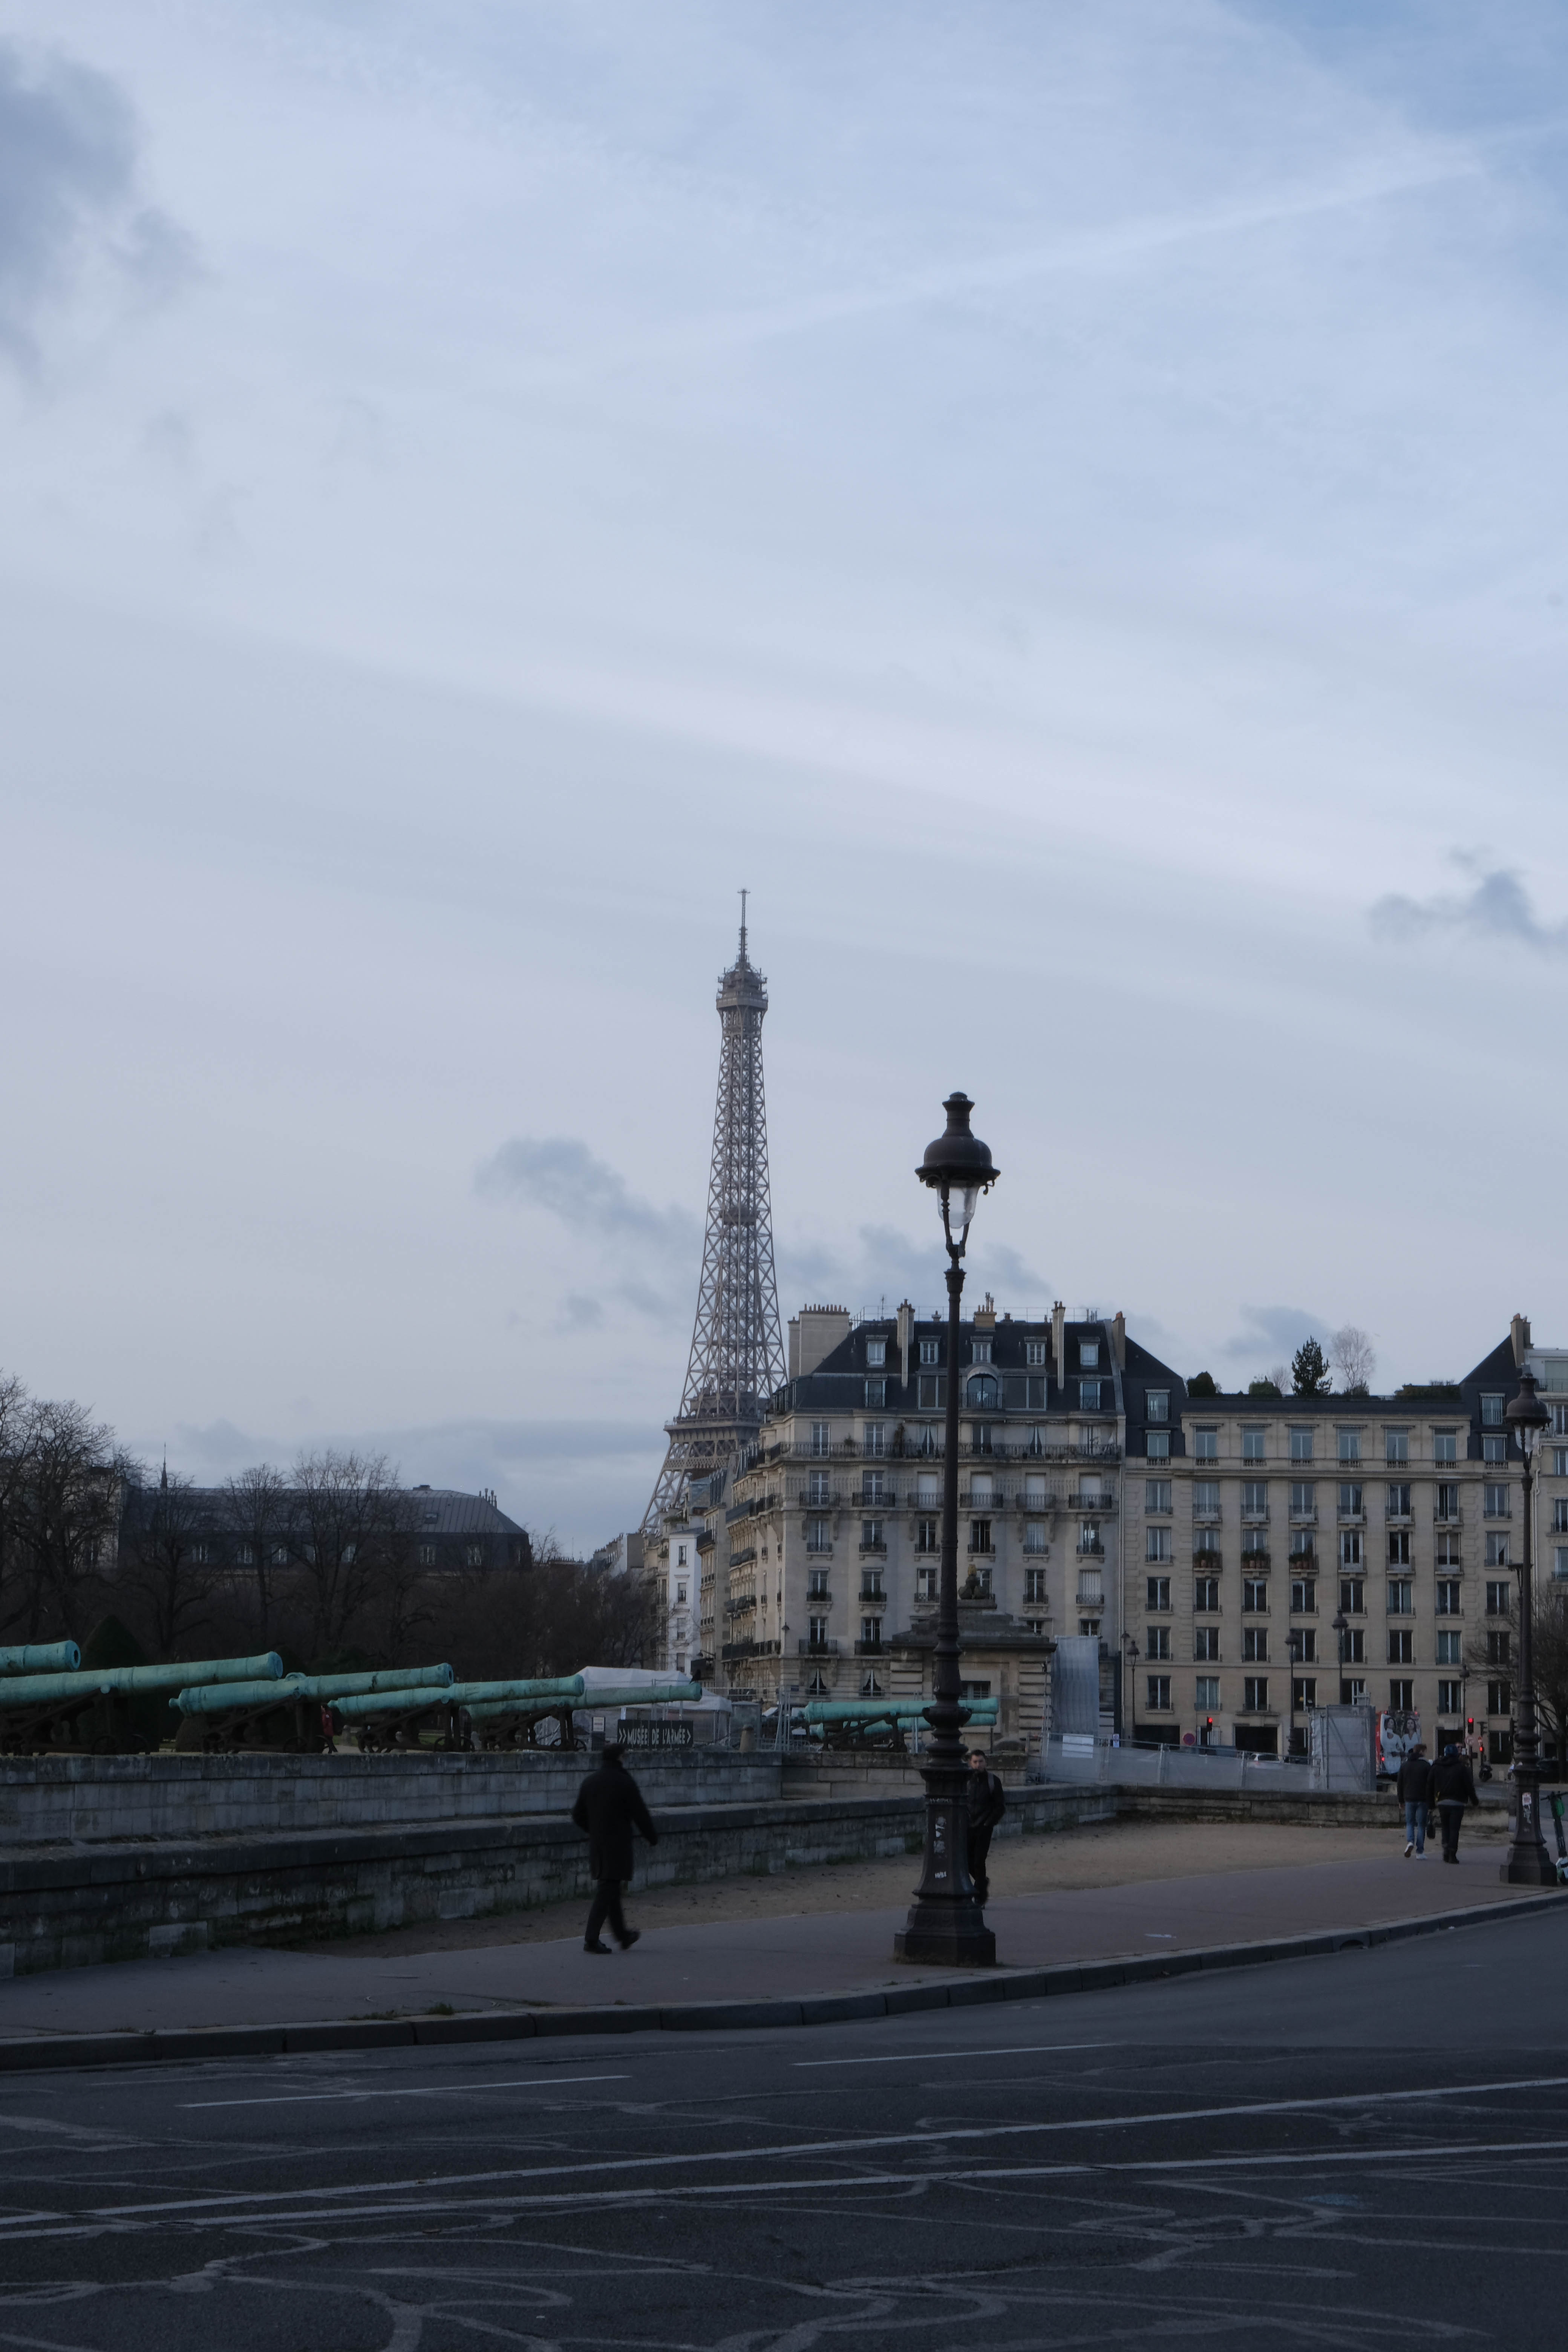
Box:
0, 1642, 703, 1755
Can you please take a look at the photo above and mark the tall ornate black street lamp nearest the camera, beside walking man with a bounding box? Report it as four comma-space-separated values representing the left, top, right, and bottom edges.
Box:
893, 1094, 999, 1969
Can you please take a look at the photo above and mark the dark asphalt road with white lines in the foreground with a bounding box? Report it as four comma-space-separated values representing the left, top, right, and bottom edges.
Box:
0, 1917, 1568, 2352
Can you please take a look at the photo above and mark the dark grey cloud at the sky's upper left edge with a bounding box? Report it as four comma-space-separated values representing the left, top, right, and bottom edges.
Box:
0, 42, 195, 369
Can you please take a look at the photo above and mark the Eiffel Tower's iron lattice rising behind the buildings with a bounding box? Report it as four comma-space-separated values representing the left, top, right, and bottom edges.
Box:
642, 891, 785, 1536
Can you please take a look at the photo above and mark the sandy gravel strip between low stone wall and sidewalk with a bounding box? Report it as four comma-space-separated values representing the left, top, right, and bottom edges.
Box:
276, 1816, 1479, 1957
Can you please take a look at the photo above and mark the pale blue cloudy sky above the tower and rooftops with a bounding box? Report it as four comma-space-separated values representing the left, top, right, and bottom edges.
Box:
0, 0, 1568, 1548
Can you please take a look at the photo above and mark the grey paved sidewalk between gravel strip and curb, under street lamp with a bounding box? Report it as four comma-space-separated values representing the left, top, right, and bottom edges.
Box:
0, 1846, 1530, 2039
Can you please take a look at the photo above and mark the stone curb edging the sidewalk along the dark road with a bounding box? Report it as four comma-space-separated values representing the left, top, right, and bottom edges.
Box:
0, 1889, 1568, 2075
